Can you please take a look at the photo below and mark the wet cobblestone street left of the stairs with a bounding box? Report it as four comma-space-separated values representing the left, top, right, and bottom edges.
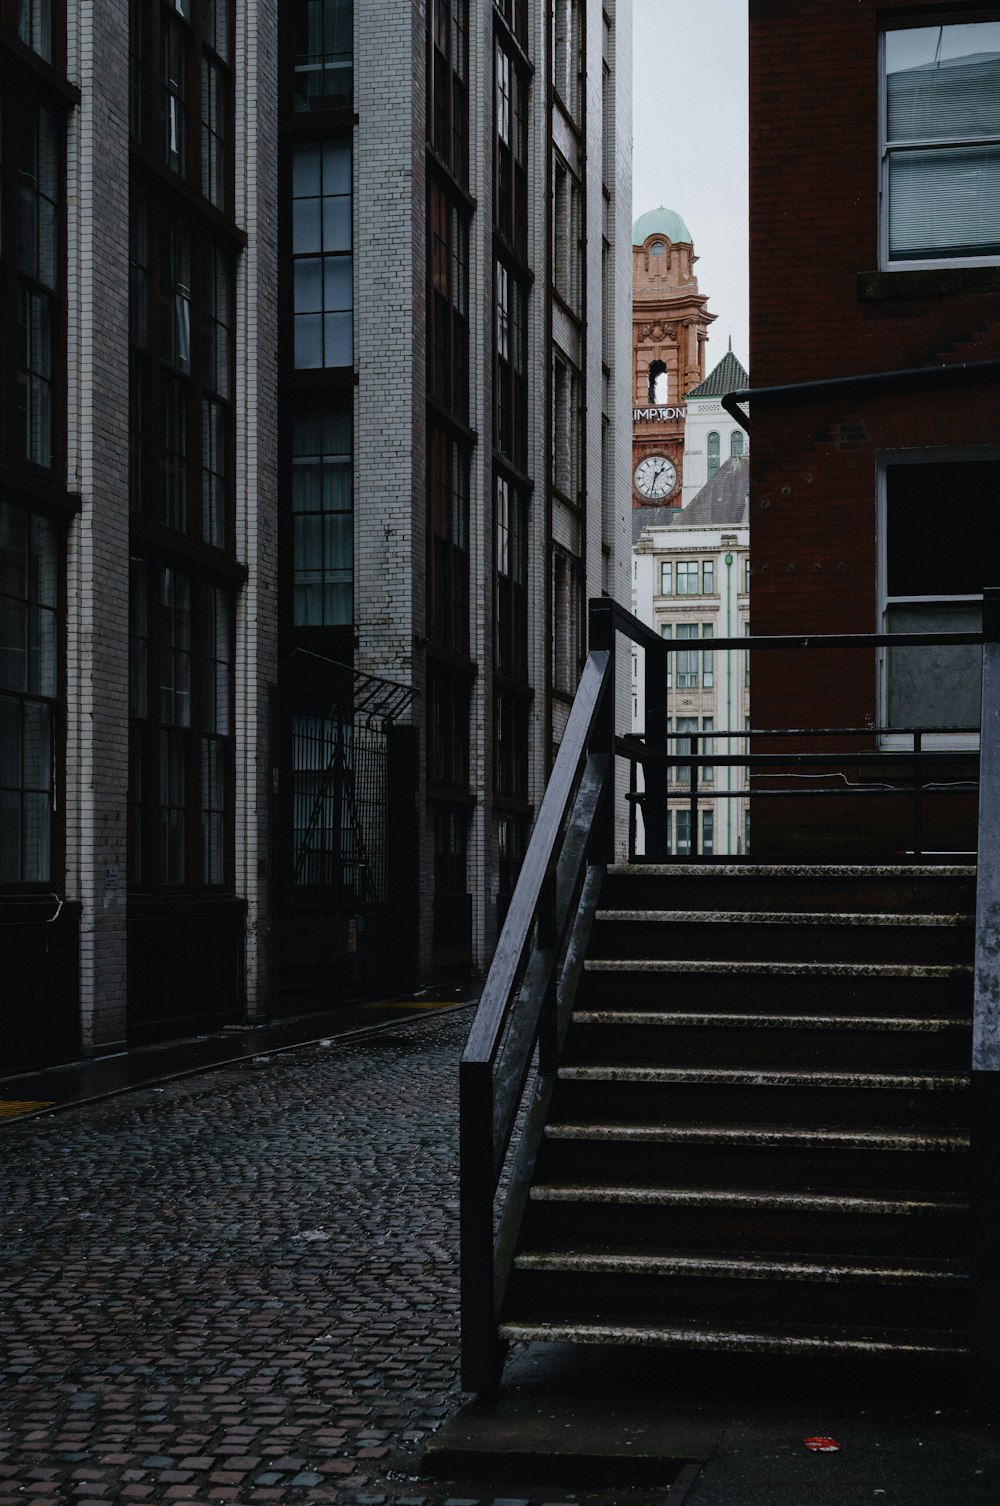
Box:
0, 1011, 680, 1506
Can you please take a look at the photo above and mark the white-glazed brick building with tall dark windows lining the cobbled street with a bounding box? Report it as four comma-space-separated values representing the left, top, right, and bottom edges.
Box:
0, 0, 631, 1072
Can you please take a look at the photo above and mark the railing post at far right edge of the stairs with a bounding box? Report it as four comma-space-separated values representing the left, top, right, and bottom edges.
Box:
970, 586, 1000, 1416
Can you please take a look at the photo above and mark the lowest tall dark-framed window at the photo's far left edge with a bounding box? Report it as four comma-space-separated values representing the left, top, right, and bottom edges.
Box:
0, 503, 60, 884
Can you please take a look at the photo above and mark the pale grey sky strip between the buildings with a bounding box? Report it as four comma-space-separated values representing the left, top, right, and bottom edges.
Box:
633, 0, 750, 372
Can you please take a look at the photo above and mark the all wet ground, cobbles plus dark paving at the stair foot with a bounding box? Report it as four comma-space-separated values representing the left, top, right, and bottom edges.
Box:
0, 1009, 1000, 1506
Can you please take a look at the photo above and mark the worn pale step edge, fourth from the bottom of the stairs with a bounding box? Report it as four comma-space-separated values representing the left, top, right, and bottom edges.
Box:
545, 1122, 970, 1154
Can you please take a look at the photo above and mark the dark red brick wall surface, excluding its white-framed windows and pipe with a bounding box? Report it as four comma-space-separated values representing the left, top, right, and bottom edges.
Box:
750, 0, 1000, 840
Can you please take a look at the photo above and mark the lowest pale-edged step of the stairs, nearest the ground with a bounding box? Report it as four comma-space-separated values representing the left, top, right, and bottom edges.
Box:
500, 1321, 968, 1358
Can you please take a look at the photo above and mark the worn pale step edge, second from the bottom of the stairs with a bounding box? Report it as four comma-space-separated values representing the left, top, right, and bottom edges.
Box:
514, 1250, 968, 1286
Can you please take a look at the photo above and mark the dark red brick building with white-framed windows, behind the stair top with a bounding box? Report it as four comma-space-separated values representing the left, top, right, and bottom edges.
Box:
740, 0, 1000, 852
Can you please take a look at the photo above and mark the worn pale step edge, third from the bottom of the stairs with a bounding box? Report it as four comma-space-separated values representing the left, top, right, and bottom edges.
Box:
530, 1182, 968, 1218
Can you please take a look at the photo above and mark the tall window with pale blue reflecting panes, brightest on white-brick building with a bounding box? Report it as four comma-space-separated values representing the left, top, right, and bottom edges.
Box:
292, 142, 354, 369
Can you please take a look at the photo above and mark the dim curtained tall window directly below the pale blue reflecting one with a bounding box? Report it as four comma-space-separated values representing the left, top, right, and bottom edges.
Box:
292, 402, 354, 628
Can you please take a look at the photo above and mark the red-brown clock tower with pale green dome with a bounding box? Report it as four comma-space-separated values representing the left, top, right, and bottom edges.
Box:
633, 206, 715, 508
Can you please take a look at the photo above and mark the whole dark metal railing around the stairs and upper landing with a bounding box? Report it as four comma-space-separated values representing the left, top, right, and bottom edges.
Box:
459, 589, 1000, 1392
